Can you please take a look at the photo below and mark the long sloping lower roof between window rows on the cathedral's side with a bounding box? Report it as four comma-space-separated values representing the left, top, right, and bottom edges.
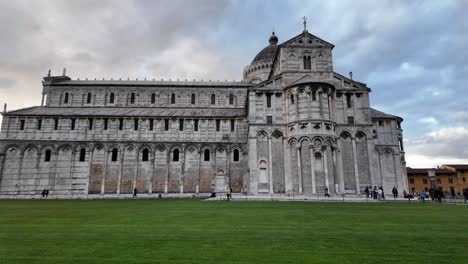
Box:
6, 106, 246, 118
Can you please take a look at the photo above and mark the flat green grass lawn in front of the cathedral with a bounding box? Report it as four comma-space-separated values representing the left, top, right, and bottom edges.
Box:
0, 200, 468, 264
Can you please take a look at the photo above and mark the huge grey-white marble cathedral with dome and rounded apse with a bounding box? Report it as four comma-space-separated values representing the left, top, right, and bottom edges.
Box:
0, 29, 408, 197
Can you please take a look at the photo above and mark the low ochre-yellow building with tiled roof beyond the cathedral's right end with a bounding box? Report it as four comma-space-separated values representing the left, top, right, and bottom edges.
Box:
407, 167, 458, 196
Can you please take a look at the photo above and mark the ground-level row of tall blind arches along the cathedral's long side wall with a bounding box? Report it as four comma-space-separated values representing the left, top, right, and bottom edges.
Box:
0, 144, 246, 194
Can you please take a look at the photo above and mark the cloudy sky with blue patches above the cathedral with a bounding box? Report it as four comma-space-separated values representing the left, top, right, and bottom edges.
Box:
0, 0, 468, 167
